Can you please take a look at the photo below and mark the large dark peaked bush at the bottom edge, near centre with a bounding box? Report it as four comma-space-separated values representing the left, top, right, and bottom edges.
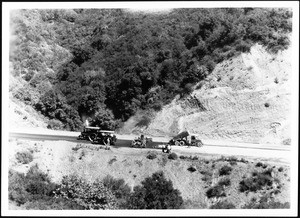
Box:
127, 171, 183, 209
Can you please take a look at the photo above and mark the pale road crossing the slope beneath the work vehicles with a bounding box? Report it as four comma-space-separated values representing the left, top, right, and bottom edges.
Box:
9, 132, 291, 163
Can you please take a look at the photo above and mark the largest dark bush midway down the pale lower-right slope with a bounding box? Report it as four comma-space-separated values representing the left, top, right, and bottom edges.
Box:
239, 168, 273, 192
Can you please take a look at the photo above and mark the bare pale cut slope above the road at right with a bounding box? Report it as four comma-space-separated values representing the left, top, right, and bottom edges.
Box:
139, 45, 292, 144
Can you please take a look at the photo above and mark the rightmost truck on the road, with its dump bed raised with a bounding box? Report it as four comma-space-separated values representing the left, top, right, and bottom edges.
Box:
168, 131, 203, 147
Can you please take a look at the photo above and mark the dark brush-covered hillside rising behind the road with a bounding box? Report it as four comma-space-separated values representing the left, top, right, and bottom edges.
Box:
9, 8, 293, 131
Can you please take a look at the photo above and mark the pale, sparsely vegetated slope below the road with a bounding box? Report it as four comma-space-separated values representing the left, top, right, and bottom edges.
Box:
9, 139, 291, 209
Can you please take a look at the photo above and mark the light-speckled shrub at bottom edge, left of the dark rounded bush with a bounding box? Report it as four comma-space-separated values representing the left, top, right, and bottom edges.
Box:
55, 175, 116, 209
